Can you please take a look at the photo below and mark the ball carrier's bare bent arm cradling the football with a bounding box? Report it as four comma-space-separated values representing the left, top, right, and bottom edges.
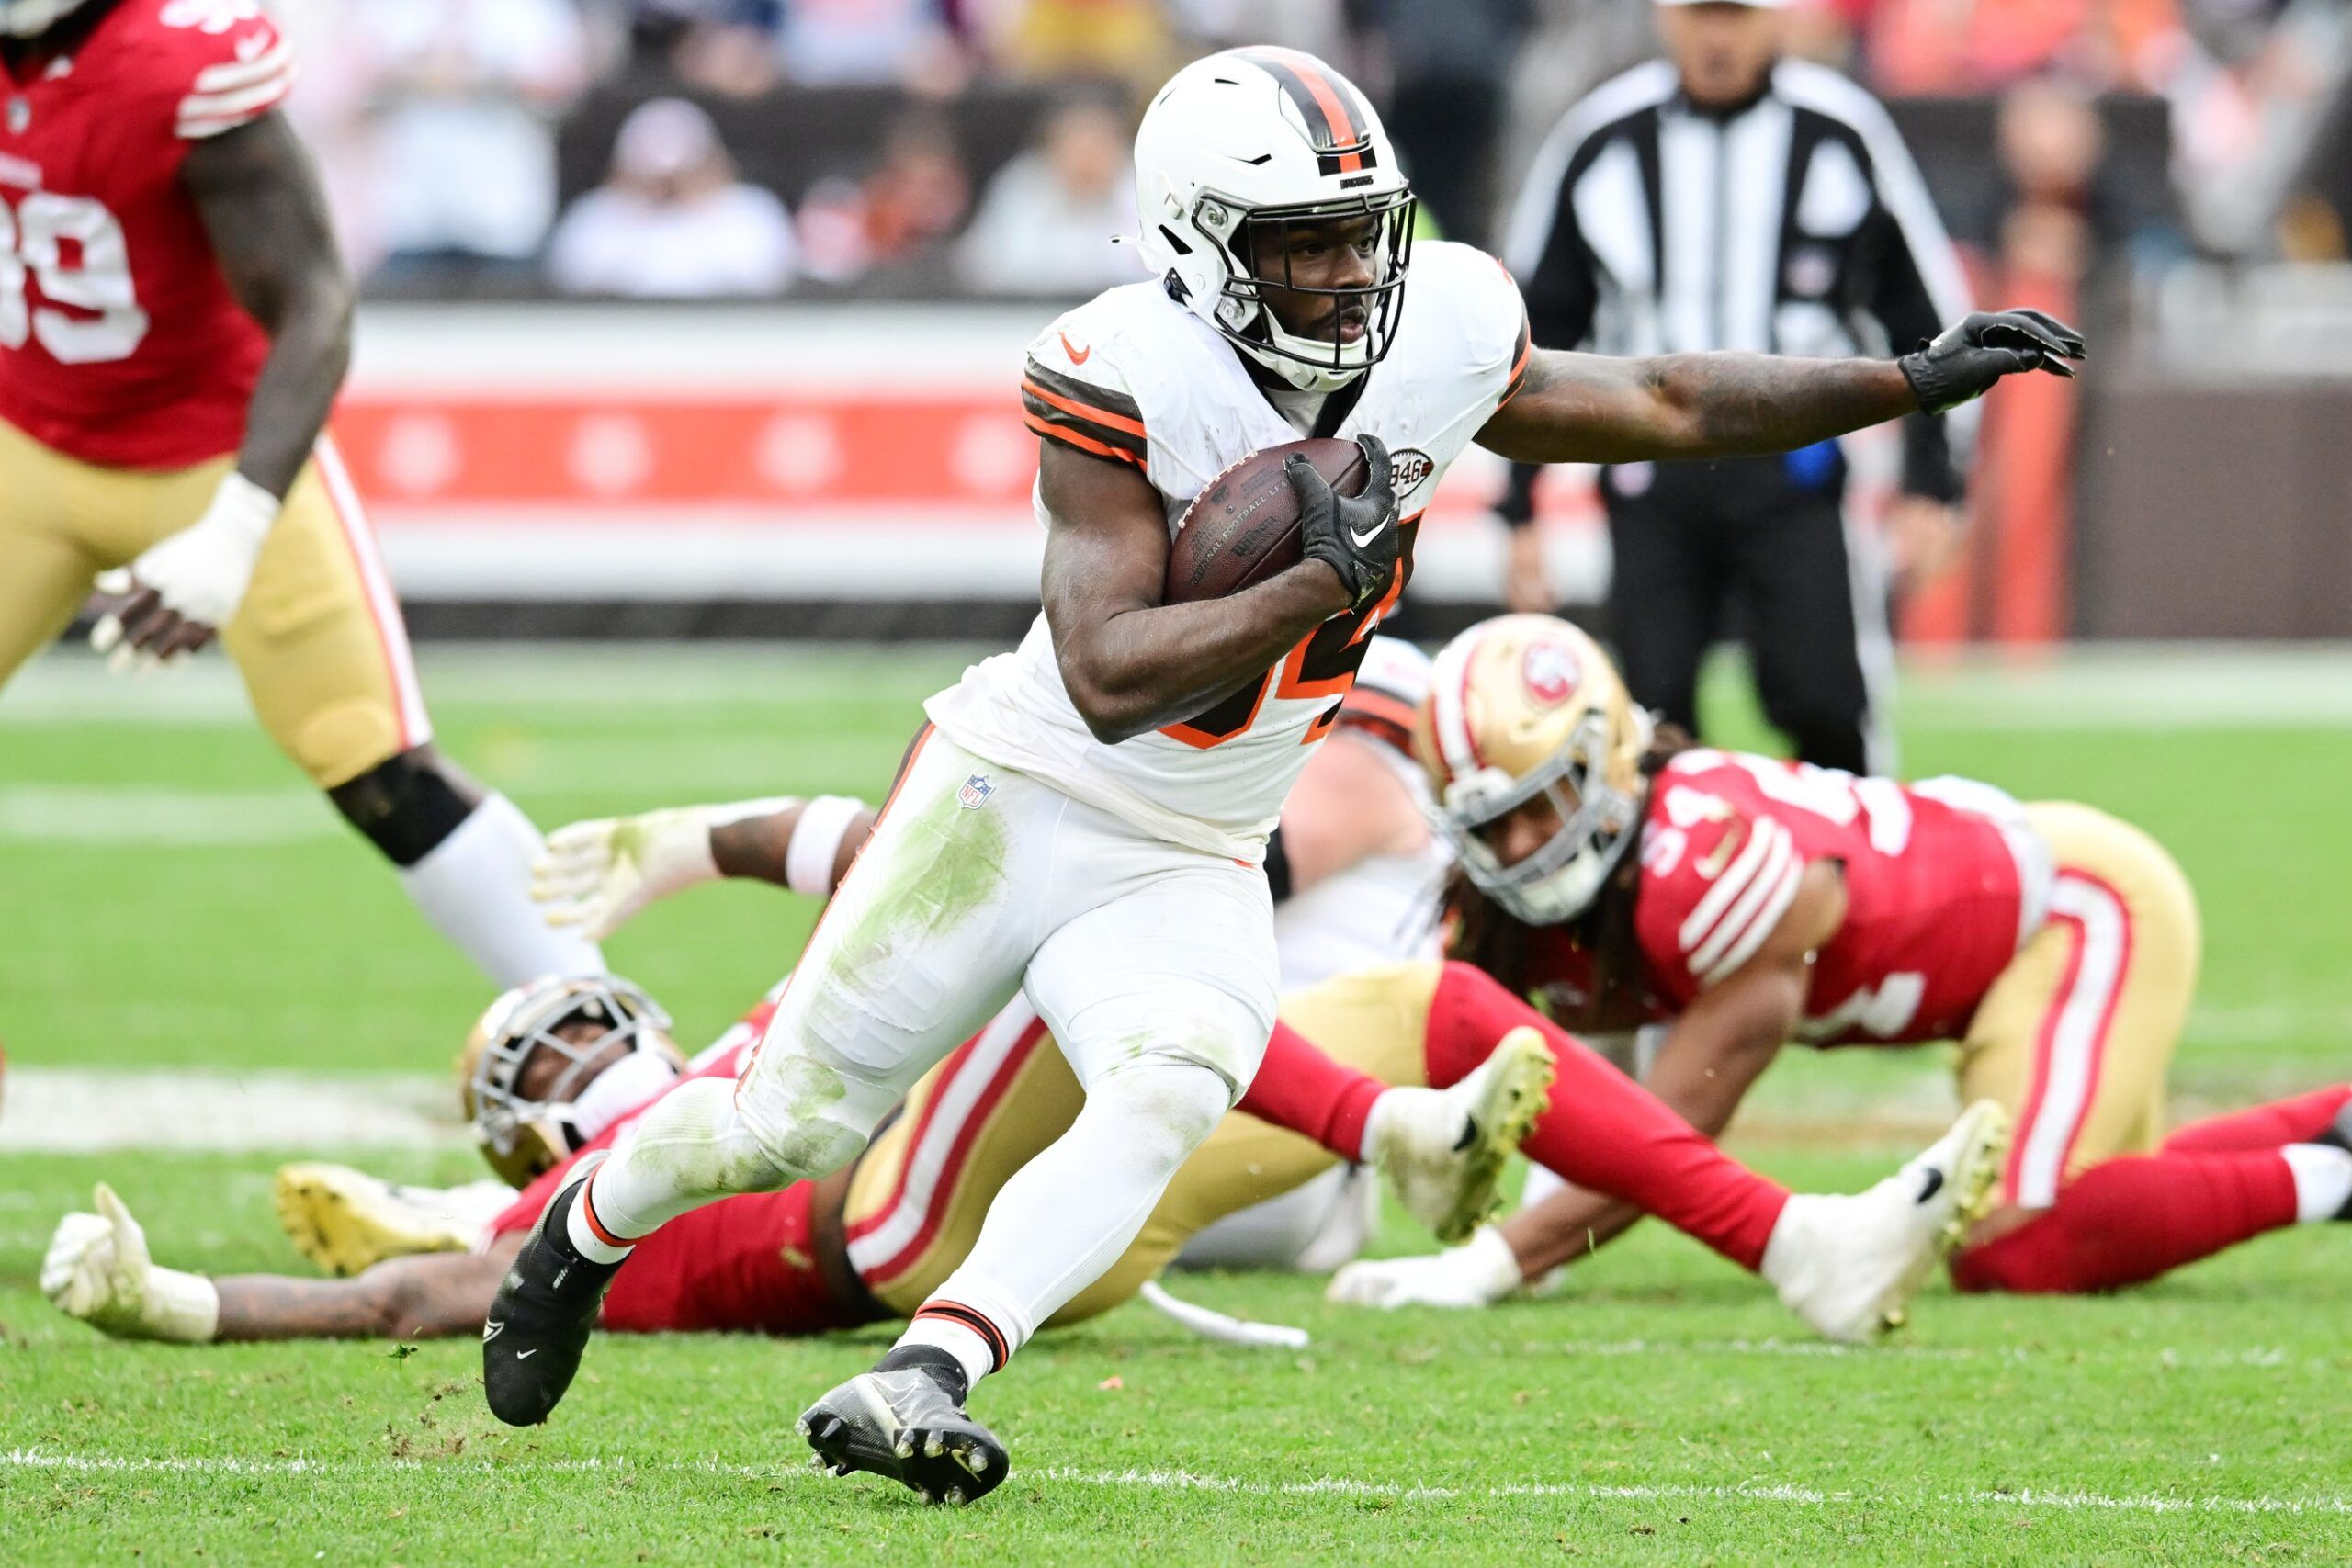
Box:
1037, 442, 1348, 743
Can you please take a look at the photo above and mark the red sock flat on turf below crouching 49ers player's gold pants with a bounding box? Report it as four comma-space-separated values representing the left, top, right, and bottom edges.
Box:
1952, 1149, 2296, 1293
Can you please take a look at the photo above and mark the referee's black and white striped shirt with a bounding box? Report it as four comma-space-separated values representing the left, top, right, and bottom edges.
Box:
1503, 62, 1973, 501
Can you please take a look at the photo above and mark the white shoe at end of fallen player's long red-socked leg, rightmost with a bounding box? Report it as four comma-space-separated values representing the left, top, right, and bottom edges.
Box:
1761, 1100, 2008, 1342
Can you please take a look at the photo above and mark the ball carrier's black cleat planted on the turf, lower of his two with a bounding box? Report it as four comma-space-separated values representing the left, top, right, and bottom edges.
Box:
799, 1349, 1007, 1505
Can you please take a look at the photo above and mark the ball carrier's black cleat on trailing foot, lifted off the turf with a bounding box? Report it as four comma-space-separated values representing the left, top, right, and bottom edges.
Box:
482, 1152, 621, 1427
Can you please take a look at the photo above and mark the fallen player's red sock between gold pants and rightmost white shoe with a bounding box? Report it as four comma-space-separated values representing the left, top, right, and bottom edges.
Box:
1425, 964, 1788, 1272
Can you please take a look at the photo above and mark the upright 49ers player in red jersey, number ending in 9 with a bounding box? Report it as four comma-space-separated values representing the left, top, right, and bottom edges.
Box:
0, 0, 602, 985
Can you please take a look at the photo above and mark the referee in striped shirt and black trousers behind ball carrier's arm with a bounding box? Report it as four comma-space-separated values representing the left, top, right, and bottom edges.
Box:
1500, 0, 1973, 773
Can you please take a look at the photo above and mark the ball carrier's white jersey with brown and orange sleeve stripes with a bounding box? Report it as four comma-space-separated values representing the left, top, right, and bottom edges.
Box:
927, 243, 1529, 863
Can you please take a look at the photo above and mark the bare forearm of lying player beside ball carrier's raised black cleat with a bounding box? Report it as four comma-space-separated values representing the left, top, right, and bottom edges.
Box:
214, 1239, 520, 1340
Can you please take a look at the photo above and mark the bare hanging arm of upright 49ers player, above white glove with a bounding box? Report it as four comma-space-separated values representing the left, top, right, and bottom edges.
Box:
181, 113, 353, 499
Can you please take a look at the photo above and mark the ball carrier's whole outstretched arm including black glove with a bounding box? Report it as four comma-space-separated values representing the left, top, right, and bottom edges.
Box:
1477, 310, 2084, 463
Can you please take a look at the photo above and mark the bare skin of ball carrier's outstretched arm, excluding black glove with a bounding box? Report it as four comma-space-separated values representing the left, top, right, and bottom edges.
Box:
1477, 350, 1919, 463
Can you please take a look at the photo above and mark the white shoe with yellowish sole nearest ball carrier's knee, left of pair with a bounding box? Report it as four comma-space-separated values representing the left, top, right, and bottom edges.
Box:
1364, 1025, 1555, 1246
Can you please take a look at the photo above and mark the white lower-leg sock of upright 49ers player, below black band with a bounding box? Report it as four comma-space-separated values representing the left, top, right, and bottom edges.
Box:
400, 795, 605, 987
